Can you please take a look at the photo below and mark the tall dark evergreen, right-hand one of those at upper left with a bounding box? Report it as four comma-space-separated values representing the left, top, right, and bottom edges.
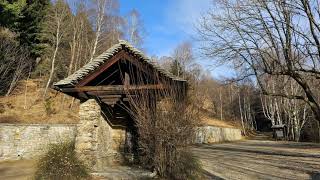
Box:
17, 0, 50, 59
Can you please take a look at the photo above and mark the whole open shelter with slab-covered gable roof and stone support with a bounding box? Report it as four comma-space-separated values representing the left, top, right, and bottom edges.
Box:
54, 41, 187, 171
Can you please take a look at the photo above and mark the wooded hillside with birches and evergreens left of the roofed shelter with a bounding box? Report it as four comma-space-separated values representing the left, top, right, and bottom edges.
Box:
0, 0, 142, 123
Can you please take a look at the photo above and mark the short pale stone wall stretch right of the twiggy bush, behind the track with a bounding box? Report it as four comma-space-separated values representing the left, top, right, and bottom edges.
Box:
195, 126, 242, 144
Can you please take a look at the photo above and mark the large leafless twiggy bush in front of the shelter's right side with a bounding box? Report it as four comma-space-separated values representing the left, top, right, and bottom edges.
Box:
131, 99, 202, 179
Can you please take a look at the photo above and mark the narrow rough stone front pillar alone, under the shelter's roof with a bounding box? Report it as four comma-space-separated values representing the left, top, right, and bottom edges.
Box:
75, 99, 101, 171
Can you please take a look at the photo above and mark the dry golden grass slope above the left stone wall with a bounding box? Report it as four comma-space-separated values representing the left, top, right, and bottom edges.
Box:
0, 79, 79, 123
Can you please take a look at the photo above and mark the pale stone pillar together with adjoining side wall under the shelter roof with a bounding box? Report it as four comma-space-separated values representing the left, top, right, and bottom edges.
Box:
75, 99, 126, 171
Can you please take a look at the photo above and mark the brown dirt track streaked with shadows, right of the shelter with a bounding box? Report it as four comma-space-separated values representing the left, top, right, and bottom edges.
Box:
193, 140, 320, 180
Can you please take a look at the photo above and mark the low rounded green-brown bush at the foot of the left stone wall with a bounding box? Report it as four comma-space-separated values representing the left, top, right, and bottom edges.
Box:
35, 142, 90, 180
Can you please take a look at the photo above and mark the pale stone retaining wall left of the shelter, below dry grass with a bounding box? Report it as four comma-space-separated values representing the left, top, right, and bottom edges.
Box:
0, 124, 76, 160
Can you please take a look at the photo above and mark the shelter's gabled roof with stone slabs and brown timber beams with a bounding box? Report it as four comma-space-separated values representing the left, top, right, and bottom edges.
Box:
54, 40, 187, 106
